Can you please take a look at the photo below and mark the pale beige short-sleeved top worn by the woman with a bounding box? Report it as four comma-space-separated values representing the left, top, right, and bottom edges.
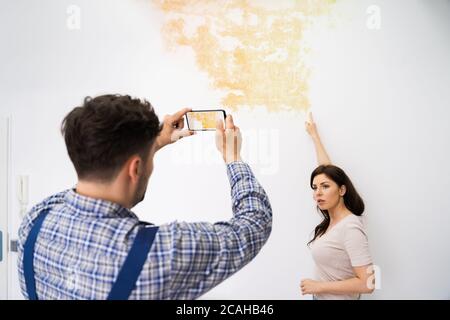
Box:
310, 214, 372, 300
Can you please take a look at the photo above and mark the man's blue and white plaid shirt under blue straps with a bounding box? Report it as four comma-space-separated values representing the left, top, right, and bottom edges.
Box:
18, 162, 272, 300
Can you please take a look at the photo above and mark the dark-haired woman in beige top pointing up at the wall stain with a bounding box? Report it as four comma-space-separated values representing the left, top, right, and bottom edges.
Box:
300, 115, 374, 300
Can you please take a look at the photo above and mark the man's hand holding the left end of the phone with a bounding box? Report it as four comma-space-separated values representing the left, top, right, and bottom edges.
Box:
156, 108, 195, 151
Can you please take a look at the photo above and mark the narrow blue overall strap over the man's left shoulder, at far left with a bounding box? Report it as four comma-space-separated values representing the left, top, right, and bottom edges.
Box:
23, 210, 48, 300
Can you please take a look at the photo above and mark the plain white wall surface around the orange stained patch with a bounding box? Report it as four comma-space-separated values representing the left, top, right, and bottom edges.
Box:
0, 0, 450, 299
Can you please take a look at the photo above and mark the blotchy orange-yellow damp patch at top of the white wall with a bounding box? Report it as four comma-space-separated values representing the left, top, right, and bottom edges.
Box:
152, 0, 335, 111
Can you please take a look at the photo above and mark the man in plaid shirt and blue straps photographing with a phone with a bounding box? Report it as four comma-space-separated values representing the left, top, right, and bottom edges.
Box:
18, 95, 272, 300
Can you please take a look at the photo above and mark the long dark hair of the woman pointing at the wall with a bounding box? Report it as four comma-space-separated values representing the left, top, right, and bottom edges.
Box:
308, 164, 364, 245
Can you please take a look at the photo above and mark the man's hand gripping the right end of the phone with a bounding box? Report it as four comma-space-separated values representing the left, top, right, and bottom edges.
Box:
216, 114, 242, 164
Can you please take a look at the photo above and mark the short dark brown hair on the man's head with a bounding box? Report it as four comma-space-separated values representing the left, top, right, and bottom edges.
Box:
61, 95, 161, 182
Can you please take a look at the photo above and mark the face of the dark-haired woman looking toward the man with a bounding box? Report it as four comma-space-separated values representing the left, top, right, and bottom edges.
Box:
312, 173, 345, 210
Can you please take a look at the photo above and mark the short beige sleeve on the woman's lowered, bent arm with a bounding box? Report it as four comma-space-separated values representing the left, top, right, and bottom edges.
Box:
344, 221, 372, 267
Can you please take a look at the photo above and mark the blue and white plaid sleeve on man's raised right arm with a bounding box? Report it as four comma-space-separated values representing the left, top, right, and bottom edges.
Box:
170, 162, 272, 299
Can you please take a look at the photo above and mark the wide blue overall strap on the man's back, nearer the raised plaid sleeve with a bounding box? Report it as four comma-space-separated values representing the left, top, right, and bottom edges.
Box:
107, 226, 158, 300
